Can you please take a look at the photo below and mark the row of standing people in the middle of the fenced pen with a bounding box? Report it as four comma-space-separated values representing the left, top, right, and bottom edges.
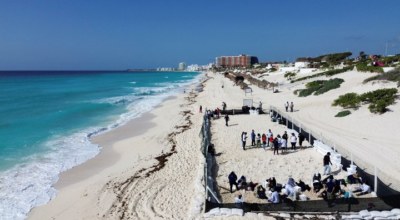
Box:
240, 129, 305, 152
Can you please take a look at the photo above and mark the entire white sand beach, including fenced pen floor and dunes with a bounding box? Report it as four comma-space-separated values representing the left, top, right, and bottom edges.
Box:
29, 71, 400, 219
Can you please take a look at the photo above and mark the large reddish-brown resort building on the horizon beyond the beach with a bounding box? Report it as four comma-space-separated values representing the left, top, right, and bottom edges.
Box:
215, 54, 258, 67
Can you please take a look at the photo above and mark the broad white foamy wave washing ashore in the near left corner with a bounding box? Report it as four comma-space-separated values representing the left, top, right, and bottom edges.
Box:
0, 129, 99, 219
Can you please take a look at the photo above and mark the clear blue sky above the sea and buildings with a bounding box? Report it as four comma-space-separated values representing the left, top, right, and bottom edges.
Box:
0, 0, 400, 70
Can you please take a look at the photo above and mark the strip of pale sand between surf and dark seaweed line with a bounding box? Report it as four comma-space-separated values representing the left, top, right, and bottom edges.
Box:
28, 73, 206, 219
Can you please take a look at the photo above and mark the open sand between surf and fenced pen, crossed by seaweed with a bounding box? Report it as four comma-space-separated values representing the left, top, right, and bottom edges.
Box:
29, 85, 208, 219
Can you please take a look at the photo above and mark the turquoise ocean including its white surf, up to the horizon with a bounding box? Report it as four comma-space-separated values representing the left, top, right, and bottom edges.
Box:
0, 71, 202, 219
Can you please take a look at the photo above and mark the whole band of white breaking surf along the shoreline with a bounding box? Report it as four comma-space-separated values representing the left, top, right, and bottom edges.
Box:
0, 71, 203, 219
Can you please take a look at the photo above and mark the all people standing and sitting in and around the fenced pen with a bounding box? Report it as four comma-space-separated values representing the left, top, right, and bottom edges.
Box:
200, 99, 371, 205
